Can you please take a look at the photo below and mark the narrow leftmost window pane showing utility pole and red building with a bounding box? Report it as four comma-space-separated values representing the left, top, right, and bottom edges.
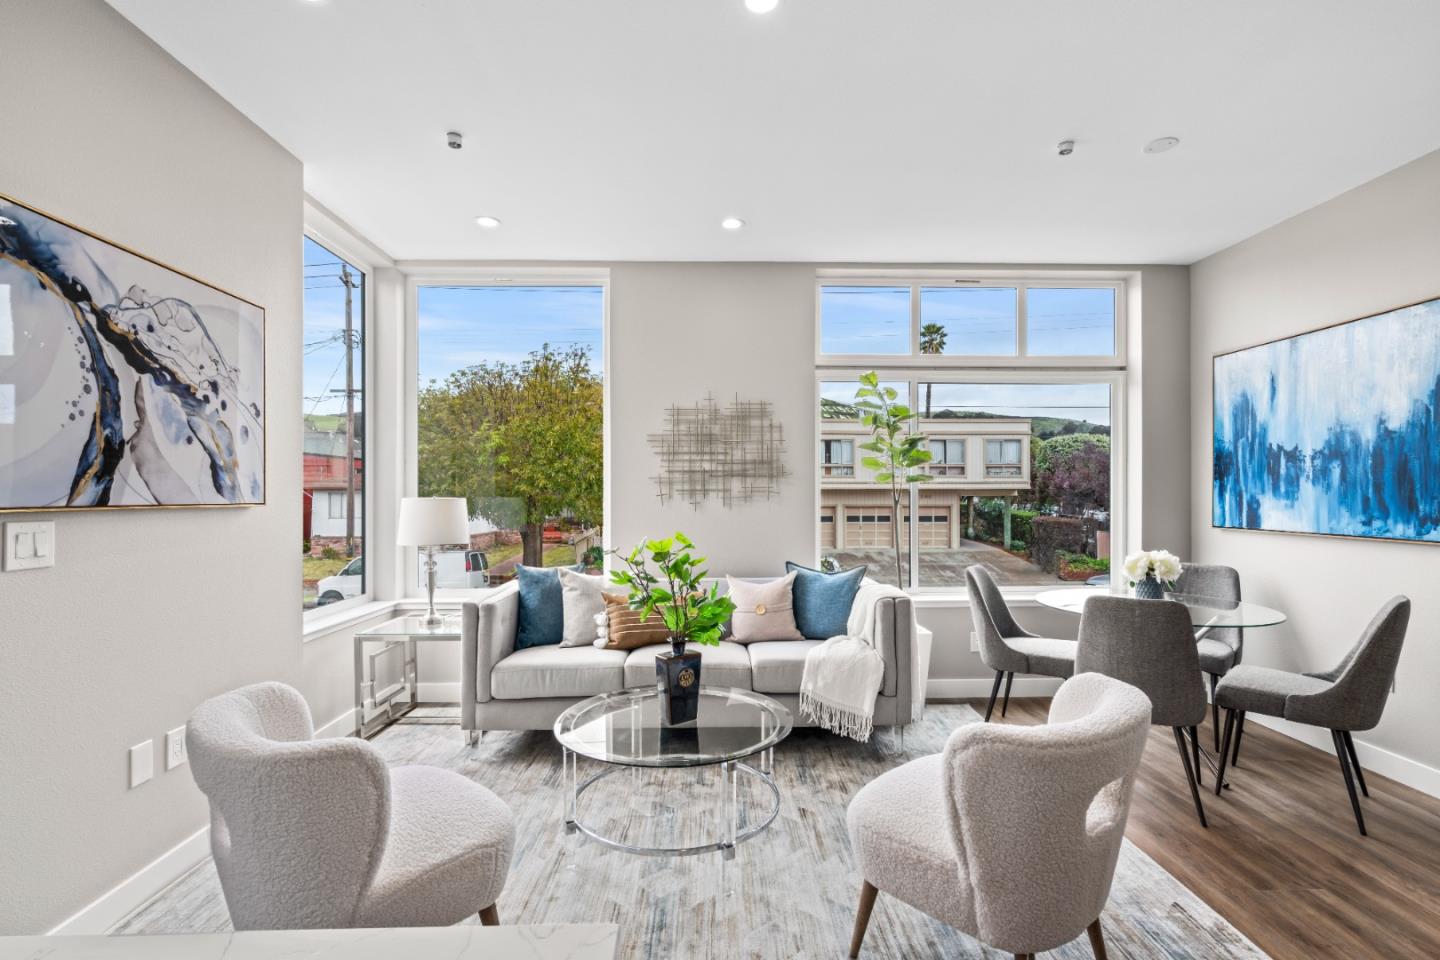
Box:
301, 237, 366, 610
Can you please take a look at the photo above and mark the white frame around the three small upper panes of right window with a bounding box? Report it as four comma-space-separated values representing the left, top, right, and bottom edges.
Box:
815, 276, 1129, 370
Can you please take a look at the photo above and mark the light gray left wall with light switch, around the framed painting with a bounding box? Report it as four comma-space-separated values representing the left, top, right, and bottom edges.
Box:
0, 0, 302, 934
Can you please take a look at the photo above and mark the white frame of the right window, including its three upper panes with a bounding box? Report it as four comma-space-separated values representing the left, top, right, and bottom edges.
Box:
811, 269, 1133, 602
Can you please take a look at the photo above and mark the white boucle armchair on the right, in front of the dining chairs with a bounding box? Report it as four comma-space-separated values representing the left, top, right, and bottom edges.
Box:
847, 674, 1151, 960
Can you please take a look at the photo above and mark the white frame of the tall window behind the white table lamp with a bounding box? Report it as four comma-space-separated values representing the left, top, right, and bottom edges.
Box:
397, 270, 610, 602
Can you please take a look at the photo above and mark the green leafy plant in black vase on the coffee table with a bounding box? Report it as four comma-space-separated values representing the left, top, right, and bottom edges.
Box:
611, 533, 734, 724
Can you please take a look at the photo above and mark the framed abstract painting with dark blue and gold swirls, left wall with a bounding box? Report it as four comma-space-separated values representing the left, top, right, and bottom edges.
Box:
0, 196, 265, 510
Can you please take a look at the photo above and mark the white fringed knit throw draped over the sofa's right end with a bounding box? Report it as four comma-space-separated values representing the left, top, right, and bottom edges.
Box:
801, 580, 904, 741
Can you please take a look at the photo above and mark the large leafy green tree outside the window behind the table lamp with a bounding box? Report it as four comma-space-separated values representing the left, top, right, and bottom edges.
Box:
418, 344, 603, 566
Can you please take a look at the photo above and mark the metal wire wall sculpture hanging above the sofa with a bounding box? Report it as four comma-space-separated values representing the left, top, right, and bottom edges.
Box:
649, 394, 791, 510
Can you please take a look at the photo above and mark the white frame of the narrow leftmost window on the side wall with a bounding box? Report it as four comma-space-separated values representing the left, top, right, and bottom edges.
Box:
300, 227, 380, 624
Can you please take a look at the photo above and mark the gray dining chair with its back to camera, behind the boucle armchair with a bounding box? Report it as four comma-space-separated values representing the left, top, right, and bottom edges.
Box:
1076, 596, 1210, 828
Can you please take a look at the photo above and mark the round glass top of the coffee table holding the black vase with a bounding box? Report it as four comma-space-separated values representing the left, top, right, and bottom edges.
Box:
554, 685, 792, 767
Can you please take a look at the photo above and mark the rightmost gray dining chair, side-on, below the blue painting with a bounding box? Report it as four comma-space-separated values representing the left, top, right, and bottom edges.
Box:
1215, 596, 1410, 836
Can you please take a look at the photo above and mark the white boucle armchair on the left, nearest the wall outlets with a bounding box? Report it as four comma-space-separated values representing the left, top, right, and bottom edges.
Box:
186, 684, 516, 930
